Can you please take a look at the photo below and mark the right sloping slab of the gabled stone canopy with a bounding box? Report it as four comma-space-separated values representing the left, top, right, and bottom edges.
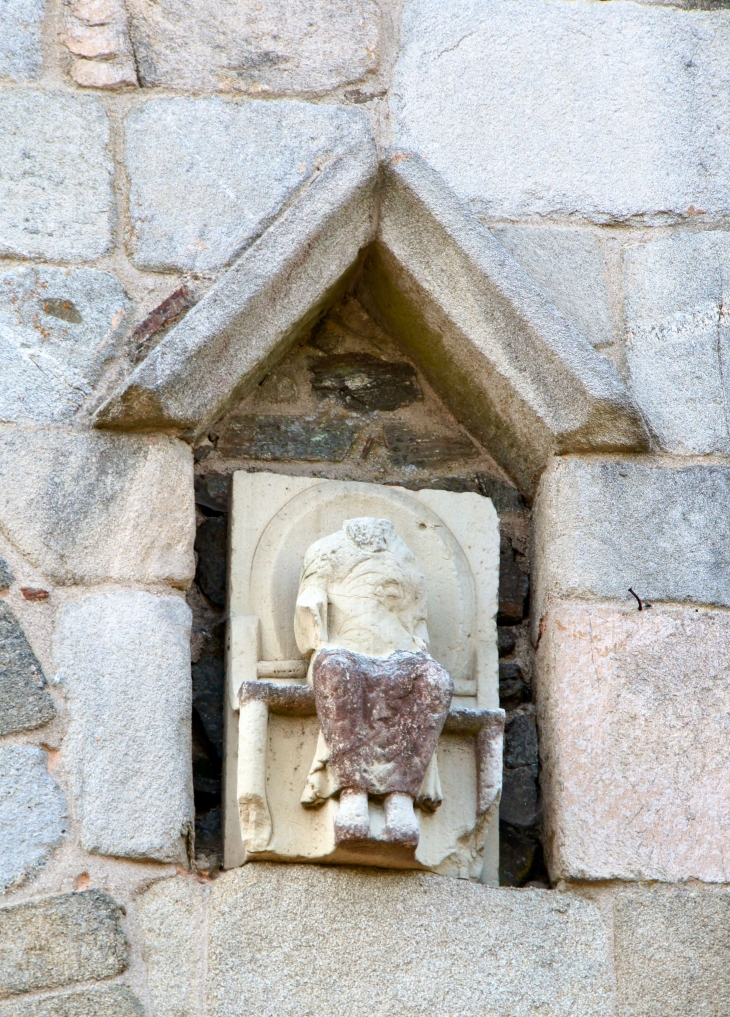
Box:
374, 152, 649, 494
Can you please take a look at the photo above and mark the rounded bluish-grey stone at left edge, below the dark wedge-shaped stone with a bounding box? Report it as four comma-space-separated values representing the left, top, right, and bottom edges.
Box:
0, 745, 67, 890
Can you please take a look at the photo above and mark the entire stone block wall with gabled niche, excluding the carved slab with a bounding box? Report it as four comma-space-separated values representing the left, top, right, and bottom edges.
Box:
0, 0, 730, 1017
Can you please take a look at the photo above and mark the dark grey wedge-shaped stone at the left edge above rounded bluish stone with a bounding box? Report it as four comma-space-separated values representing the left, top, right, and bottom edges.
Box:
0, 601, 56, 734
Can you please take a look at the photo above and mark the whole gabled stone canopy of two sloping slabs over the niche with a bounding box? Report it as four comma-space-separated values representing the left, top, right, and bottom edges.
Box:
96, 147, 649, 495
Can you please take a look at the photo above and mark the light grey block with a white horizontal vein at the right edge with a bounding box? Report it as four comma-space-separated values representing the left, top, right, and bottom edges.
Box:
623, 232, 730, 455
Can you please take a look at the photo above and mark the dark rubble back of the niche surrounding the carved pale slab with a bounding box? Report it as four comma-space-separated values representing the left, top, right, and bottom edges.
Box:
188, 290, 547, 885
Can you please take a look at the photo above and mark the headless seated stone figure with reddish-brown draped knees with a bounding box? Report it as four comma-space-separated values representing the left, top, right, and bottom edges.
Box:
294, 517, 453, 847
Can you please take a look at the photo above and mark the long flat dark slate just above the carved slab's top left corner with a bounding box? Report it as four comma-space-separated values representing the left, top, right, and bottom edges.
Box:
217, 415, 362, 463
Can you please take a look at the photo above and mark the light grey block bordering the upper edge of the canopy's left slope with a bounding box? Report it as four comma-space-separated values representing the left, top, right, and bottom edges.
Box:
126, 98, 368, 271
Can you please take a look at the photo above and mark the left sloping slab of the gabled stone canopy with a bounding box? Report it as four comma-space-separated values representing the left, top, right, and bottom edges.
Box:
97, 127, 377, 437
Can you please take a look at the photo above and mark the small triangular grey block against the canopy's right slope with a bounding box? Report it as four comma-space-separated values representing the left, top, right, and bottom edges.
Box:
491, 226, 616, 349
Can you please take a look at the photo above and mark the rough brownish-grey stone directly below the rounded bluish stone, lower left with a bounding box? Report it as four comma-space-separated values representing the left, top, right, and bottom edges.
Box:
0, 890, 129, 997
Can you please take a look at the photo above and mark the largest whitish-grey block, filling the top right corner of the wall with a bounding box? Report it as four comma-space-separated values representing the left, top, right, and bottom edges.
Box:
393, 0, 730, 222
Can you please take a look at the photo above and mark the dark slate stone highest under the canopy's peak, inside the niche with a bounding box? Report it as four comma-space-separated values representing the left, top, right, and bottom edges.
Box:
309, 353, 423, 410
